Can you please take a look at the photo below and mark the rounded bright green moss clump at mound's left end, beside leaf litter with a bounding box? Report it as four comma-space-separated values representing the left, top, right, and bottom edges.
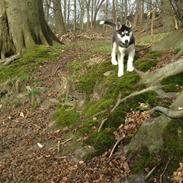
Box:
53, 106, 80, 127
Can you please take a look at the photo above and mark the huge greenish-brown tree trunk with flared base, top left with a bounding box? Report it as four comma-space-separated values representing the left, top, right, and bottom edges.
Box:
0, 0, 58, 59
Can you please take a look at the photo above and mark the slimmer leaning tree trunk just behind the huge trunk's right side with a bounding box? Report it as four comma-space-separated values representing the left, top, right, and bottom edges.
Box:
53, 0, 66, 35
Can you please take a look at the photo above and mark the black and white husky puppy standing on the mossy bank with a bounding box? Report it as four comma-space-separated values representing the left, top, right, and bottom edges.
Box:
100, 21, 135, 77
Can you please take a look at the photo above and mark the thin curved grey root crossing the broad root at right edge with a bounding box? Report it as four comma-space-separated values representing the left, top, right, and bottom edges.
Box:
150, 106, 183, 118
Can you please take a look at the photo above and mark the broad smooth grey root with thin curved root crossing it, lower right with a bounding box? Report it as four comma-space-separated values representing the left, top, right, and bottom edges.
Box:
125, 92, 183, 153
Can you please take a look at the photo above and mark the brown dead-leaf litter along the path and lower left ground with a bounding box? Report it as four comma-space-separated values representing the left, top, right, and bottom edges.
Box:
0, 30, 182, 183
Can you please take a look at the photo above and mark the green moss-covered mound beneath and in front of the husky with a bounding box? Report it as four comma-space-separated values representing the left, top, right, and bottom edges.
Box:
54, 43, 166, 157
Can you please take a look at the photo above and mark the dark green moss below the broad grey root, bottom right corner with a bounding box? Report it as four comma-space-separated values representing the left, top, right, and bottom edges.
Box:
130, 118, 183, 177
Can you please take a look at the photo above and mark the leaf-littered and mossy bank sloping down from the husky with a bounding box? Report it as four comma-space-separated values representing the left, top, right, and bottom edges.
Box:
0, 31, 182, 183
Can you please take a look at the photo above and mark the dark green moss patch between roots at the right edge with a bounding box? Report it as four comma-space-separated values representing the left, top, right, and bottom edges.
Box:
161, 73, 183, 92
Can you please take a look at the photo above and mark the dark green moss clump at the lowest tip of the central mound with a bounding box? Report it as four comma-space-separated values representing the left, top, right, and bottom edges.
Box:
85, 128, 115, 154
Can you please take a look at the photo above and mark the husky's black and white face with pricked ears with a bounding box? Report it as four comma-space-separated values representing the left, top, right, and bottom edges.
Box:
116, 23, 132, 46
